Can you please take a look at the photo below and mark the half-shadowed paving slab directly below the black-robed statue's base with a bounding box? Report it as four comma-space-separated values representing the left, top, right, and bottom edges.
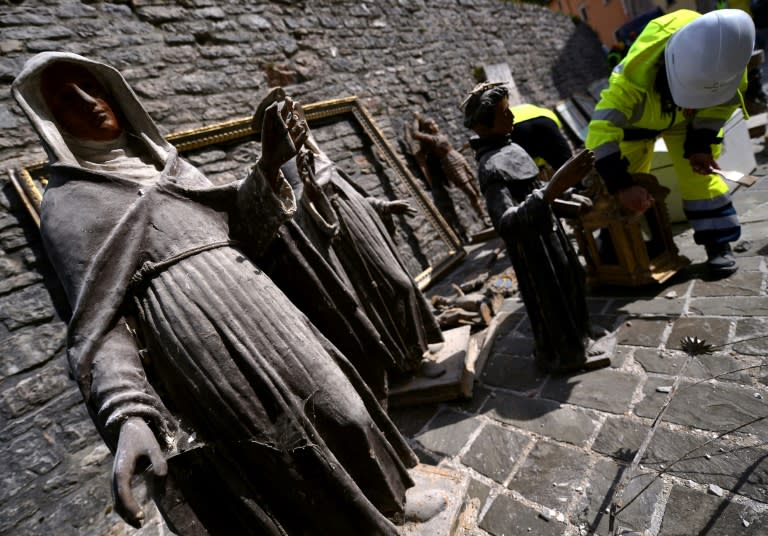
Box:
541, 368, 640, 413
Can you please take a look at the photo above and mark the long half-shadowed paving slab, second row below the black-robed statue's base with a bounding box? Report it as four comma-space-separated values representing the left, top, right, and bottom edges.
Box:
483, 393, 597, 445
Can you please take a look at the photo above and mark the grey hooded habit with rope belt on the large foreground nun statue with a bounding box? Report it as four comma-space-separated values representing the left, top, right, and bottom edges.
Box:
13, 53, 416, 535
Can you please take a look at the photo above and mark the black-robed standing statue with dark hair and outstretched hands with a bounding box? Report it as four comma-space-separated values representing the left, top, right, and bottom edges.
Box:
462, 84, 610, 372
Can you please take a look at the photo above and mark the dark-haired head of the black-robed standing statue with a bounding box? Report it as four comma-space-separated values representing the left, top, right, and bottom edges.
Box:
464, 85, 515, 138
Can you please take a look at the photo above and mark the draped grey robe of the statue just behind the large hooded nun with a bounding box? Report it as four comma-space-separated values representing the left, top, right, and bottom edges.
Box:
282, 144, 443, 373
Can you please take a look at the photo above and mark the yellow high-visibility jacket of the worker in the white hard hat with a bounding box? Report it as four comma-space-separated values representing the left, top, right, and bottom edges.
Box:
585, 9, 747, 192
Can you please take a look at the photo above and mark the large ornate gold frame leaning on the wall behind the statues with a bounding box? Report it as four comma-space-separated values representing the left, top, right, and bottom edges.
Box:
9, 96, 466, 289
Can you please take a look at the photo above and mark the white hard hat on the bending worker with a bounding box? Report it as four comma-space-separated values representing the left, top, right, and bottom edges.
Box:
664, 9, 755, 108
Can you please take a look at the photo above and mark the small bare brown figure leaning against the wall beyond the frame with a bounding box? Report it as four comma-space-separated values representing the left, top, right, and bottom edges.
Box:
408, 112, 487, 223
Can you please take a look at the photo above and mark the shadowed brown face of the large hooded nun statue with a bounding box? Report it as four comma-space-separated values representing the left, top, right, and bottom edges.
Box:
41, 61, 122, 141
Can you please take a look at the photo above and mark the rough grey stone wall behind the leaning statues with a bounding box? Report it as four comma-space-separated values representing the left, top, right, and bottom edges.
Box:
0, 0, 606, 535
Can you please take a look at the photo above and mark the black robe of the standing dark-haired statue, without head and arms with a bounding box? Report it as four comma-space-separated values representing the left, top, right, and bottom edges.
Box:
470, 136, 590, 371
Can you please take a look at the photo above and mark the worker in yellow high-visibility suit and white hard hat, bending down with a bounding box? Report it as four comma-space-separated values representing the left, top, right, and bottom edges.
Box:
585, 9, 755, 276
